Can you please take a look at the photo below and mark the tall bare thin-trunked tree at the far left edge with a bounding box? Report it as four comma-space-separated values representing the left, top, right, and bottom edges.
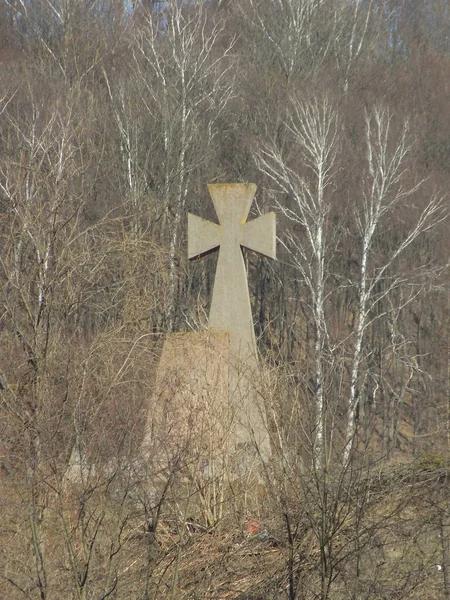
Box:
0, 85, 91, 598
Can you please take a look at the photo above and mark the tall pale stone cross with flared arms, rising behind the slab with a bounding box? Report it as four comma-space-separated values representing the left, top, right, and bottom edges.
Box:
188, 183, 276, 460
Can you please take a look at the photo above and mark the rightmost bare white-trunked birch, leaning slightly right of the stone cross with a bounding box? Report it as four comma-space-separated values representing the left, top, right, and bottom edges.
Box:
344, 107, 446, 461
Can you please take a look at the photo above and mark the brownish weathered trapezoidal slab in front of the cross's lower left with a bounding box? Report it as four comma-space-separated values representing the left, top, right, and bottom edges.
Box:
142, 331, 232, 471
